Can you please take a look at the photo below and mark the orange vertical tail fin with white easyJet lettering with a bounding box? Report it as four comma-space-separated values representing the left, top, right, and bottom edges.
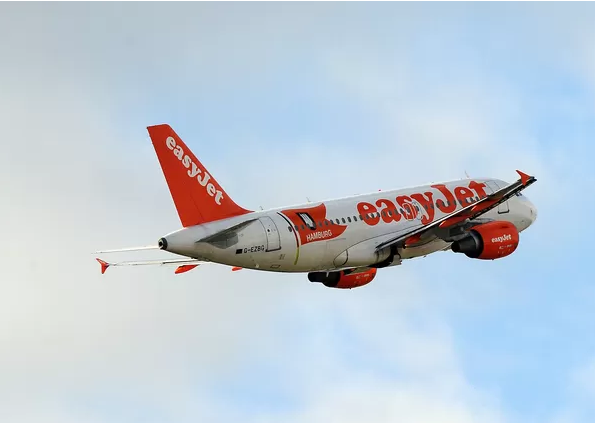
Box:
147, 124, 250, 227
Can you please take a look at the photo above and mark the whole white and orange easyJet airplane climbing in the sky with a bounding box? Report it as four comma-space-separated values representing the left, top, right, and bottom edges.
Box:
96, 124, 537, 289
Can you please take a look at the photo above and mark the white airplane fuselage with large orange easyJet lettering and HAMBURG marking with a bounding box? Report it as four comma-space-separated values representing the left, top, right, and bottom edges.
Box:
164, 179, 537, 272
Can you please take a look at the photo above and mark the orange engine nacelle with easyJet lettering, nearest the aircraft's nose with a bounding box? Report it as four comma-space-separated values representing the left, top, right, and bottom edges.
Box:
451, 221, 519, 260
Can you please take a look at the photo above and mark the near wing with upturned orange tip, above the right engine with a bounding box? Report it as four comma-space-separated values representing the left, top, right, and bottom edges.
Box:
376, 170, 537, 250
